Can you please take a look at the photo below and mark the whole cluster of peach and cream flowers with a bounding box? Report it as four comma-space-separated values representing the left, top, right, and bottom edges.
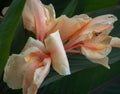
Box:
4, 0, 120, 94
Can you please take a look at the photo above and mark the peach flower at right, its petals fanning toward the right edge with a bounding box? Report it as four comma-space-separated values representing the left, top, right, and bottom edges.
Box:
62, 14, 120, 68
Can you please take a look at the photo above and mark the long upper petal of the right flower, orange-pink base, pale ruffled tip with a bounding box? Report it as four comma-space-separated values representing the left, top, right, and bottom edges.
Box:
65, 14, 117, 48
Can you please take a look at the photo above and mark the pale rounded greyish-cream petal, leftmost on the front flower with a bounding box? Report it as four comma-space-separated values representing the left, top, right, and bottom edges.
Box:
3, 54, 26, 89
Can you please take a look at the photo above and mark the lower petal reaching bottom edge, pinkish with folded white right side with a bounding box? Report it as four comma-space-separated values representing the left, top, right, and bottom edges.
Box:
23, 58, 51, 94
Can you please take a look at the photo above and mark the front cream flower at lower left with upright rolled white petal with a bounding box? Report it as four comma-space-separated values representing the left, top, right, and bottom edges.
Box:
4, 31, 70, 94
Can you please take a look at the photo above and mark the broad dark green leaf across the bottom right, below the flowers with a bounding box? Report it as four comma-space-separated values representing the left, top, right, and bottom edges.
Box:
38, 62, 120, 94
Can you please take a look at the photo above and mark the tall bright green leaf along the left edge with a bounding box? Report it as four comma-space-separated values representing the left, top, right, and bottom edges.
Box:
0, 0, 25, 76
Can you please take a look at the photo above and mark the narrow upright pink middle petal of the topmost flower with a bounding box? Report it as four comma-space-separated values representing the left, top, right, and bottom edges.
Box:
34, 0, 52, 41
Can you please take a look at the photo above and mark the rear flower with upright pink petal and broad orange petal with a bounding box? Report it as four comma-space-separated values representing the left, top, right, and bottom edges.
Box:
22, 0, 91, 41
